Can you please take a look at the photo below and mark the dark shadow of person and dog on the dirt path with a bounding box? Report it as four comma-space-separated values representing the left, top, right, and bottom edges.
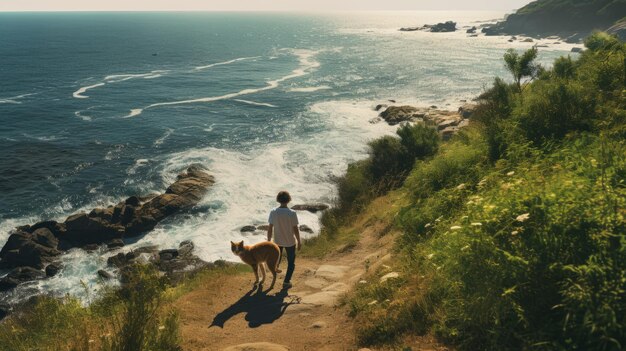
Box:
209, 285, 300, 328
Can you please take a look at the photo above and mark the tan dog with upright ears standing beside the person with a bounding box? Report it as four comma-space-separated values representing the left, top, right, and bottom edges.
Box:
230, 241, 281, 290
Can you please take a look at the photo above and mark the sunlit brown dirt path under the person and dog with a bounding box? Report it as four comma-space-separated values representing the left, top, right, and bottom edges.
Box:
175, 224, 438, 351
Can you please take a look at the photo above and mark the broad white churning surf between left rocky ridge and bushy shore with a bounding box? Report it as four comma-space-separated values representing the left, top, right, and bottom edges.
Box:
121, 100, 396, 261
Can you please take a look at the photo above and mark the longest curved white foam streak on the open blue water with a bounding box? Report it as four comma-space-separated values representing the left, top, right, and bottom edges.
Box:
125, 49, 320, 118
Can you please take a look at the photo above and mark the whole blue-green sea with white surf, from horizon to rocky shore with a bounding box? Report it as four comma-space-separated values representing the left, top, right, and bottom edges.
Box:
0, 12, 570, 302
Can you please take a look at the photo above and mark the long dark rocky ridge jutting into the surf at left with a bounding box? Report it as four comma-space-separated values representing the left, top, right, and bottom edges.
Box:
0, 165, 215, 290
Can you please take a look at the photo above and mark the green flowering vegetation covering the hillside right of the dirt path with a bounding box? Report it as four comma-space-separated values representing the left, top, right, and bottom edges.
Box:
340, 33, 626, 350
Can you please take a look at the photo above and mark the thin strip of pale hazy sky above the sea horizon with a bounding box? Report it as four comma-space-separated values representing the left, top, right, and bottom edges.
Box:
0, 0, 530, 11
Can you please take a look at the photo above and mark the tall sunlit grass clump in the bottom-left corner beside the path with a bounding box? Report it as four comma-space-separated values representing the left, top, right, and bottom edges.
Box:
0, 266, 181, 351
